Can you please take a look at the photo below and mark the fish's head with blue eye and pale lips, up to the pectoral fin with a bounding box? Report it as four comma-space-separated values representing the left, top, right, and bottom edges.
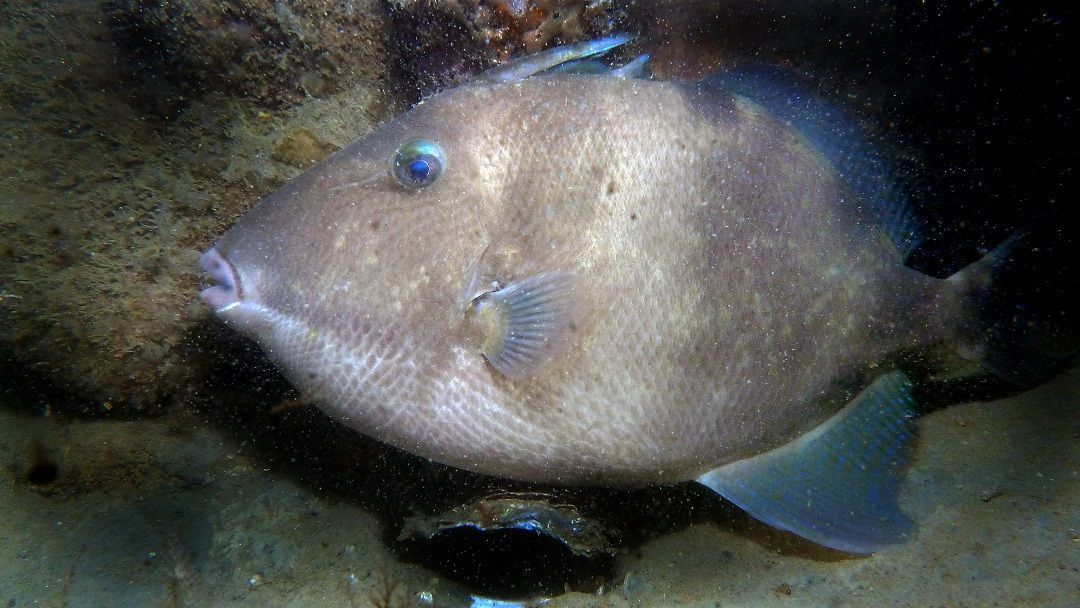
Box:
201, 83, 591, 443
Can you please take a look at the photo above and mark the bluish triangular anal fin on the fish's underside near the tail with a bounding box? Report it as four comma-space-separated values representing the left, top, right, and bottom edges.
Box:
698, 371, 916, 554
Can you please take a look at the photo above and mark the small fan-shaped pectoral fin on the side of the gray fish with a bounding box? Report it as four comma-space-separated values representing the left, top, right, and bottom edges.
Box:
467, 272, 577, 379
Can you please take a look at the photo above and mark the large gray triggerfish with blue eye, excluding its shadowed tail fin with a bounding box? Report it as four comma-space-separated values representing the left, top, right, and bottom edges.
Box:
202, 36, 1010, 553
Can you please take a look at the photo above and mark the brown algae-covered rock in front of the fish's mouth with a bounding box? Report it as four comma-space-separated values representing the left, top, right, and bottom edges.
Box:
0, 0, 388, 416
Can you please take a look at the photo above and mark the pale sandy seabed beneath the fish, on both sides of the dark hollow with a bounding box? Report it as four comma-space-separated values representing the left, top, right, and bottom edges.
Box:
0, 370, 1080, 607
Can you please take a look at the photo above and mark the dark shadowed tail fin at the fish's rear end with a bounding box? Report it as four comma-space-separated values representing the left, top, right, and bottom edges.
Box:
918, 226, 1080, 409
